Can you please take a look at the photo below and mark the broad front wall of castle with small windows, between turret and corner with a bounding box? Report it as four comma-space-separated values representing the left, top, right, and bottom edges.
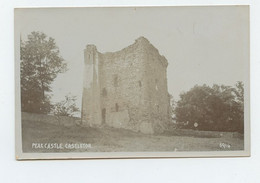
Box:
100, 38, 149, 131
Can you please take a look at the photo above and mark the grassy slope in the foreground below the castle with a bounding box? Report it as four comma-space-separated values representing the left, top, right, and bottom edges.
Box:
22, 115, 244, 152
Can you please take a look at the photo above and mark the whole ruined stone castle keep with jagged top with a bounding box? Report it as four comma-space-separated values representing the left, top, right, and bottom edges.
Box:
82, 37, 170, 134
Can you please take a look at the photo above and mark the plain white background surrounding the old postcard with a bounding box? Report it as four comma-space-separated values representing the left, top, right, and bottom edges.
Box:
0, 0, 260, 183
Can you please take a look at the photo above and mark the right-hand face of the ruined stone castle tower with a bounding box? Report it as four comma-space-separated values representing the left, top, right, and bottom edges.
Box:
144, 40, 170, 132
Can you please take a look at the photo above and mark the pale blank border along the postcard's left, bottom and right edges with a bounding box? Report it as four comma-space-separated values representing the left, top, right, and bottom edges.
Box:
14, 6, 250, 160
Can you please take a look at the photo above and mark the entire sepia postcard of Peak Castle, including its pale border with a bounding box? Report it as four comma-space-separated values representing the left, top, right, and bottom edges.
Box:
14, 5, 250, 160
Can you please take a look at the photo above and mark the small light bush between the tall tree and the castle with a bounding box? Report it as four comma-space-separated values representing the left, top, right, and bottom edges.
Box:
52, 95, 79, 116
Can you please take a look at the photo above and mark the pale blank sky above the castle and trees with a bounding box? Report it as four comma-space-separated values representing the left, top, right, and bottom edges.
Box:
15, 6, 249, 113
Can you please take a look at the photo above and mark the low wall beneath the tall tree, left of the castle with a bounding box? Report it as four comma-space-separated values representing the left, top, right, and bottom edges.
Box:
22, 112, 81, 127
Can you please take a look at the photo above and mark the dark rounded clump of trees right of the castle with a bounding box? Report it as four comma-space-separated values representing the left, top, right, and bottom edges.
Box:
174, 82, 244, 132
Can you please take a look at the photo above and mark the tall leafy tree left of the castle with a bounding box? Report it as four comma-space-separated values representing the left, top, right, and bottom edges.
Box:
20, 32, 67, 113
